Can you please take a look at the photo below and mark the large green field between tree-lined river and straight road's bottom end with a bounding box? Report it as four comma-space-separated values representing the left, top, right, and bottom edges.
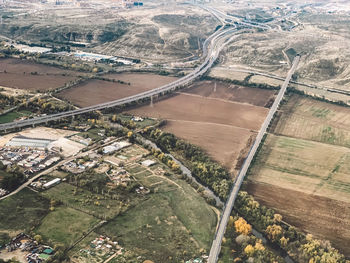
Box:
99, 161, 216, 262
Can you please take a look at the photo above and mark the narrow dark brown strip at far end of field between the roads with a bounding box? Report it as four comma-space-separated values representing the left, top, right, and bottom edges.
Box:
184, 81, 275, 107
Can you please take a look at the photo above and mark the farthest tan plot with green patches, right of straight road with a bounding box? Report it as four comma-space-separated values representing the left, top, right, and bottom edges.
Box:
273, 96, 350, 147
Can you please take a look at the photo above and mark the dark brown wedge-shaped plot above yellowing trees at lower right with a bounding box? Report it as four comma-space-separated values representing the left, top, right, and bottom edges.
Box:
247, 182, 350, 257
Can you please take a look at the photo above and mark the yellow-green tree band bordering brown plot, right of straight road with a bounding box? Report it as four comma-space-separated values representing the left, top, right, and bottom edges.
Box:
235, 191, 348, 263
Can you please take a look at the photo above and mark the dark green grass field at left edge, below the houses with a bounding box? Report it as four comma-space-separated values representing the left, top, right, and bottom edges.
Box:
0, 189, 49, 232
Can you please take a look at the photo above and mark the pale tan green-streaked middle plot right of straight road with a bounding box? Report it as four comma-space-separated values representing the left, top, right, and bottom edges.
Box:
250, 135, 350, 202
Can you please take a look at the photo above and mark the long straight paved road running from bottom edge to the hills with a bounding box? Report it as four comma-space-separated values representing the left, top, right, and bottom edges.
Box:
208, 56, 300, 263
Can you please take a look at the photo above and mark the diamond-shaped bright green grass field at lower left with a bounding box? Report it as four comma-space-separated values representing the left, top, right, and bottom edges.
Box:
35, 206, 99, 247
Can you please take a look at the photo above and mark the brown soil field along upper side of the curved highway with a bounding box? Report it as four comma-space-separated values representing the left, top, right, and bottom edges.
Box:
58, 73, 177, 107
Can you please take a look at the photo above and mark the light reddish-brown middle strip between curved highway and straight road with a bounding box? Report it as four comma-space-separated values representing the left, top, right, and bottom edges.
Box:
130, 94, 268, 131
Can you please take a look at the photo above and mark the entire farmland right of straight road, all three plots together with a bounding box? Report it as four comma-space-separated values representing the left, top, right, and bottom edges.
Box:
247, 95, 350, 256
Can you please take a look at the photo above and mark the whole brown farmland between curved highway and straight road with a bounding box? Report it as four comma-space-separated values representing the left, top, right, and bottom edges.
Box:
128, 81, 274, 171
